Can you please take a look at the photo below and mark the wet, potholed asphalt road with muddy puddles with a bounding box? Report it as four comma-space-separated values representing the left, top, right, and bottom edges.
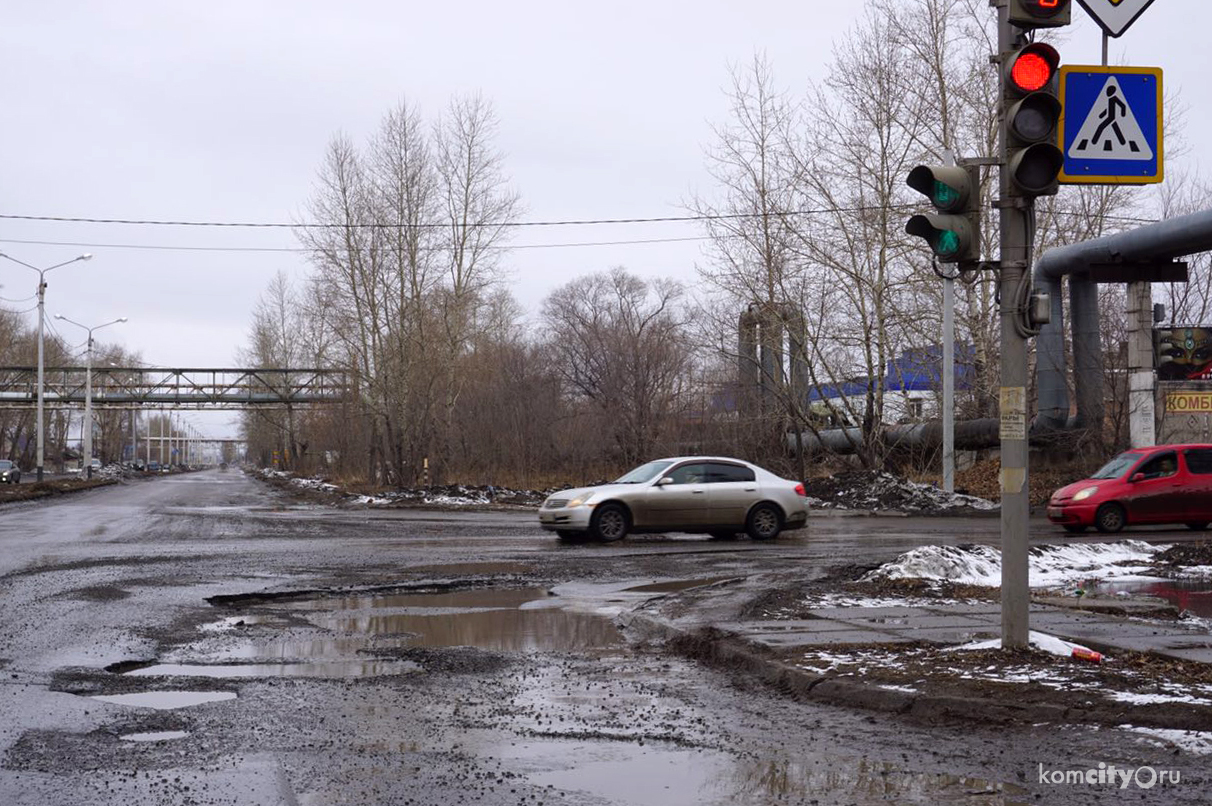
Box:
0, 470, 1207, 806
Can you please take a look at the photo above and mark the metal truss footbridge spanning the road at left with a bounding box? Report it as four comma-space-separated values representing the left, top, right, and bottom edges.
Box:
0, 366, 349, 410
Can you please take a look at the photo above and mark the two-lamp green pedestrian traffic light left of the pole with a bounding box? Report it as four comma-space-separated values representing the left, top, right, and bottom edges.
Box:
905, 165, 981, 263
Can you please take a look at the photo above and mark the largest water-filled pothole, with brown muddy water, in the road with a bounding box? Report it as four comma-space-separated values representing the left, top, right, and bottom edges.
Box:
119, 588, 624, 679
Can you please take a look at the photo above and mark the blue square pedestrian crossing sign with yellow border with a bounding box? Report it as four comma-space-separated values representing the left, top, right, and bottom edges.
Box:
1057, 64, 1165, 184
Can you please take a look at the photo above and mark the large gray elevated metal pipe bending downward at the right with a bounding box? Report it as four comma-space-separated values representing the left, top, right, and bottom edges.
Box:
1033, 210, 1212, 433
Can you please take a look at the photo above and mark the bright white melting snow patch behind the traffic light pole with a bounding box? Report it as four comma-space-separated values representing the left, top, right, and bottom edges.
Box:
862, 541, 1168, 588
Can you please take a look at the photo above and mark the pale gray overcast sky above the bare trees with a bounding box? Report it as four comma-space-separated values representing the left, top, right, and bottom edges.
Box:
0, 0, 1212, 434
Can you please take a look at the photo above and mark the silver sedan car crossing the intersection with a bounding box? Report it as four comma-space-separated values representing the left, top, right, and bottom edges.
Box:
538, 456, 808, 541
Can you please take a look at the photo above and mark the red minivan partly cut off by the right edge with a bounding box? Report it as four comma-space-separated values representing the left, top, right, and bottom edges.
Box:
1048, 445, 1212, 532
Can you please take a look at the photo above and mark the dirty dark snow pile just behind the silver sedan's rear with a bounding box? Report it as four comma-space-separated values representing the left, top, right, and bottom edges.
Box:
807, 471, 999, 513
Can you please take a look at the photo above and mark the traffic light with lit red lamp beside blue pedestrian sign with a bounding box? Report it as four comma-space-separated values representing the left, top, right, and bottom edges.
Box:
1005, 42, 1064, 198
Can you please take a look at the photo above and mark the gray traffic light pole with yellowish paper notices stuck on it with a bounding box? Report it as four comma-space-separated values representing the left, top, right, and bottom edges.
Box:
997, 2, 1034, 648
